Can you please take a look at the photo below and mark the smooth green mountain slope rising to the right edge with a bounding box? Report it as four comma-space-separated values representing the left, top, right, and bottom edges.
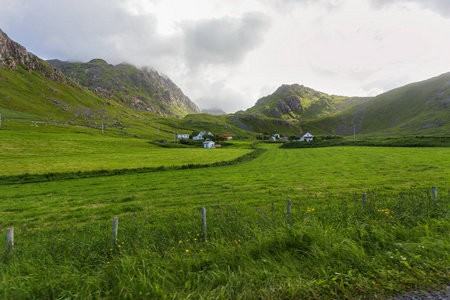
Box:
305, 73, 450, 135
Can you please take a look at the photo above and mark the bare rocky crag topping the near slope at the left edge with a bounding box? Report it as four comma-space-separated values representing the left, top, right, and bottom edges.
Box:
0, 29, 68, 83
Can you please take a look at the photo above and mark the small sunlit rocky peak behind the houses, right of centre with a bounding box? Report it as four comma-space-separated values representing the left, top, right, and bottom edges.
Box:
246, 84, 370, 120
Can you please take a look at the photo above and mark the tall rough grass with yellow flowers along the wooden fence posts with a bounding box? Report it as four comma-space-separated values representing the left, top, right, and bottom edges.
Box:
0, 189, 450, 299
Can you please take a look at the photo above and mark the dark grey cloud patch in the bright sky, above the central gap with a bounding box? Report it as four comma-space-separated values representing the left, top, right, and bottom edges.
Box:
180, 13, 270, 69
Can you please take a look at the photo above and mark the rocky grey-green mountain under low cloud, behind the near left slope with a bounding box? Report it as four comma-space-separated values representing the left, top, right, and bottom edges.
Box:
47, 59, 200, 117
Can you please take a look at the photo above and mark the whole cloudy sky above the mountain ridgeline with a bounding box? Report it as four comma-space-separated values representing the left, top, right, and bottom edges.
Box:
0, 0, 450, 113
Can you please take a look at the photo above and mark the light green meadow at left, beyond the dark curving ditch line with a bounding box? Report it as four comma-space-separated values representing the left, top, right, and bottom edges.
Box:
0, 125, 250, 176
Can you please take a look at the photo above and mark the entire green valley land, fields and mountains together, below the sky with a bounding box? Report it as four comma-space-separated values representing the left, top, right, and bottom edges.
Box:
0, 27, 450, 299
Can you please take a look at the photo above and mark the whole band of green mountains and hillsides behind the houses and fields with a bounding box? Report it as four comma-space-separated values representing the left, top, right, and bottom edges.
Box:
0, 30, 450, 140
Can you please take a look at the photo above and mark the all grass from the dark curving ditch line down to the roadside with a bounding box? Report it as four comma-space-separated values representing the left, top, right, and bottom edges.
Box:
0, 144, 450, 299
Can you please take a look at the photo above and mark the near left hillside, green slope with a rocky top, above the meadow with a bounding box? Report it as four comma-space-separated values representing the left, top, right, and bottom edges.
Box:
0, 30, 206, 140
